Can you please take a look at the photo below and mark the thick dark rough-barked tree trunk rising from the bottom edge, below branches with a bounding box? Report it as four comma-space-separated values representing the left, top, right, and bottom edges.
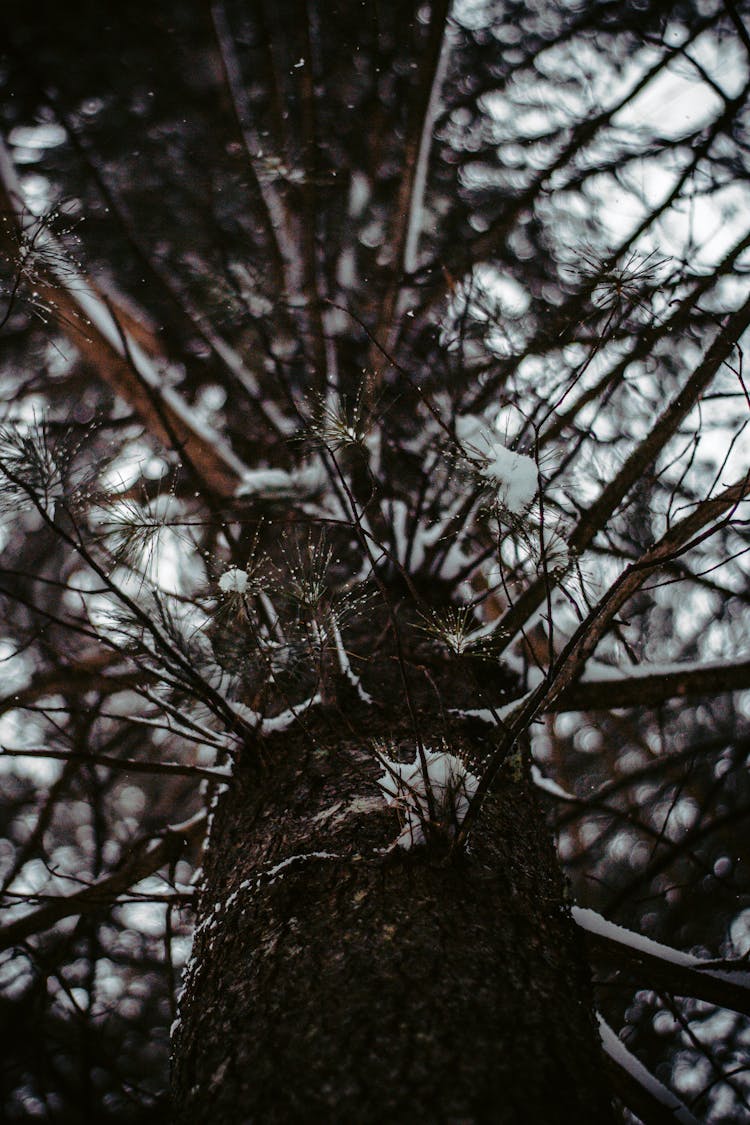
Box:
173, 709, 612, 1125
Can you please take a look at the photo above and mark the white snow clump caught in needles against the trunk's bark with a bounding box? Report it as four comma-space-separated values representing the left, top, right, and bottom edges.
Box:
378, 747, 479, 851
